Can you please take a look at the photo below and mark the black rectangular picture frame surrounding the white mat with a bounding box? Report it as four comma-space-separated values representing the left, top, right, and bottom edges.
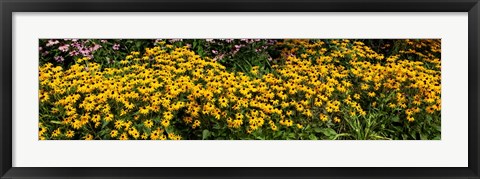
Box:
0, 0, 480, 179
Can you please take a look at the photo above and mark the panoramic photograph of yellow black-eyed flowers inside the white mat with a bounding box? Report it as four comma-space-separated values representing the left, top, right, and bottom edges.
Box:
38, 39, 441, 140
